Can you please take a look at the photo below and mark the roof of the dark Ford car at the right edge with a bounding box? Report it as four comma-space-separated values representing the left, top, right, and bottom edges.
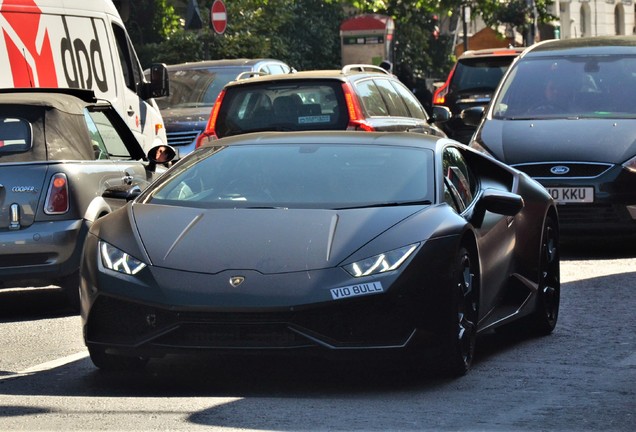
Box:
522, 36, 636, 57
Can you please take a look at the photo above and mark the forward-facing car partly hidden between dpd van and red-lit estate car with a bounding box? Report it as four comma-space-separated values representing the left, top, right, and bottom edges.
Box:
150, 58, 294, 156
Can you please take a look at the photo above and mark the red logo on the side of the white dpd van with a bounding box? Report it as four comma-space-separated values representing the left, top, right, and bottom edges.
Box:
0, 1, 58, 87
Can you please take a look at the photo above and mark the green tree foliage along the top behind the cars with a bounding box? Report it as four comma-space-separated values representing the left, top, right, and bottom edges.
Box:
120, 0, 554, 78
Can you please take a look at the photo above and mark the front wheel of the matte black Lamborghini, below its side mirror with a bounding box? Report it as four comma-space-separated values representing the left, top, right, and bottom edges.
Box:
439, 246, 478, 376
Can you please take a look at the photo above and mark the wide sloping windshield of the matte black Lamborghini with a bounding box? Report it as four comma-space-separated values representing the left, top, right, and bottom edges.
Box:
145, 144, 434, 209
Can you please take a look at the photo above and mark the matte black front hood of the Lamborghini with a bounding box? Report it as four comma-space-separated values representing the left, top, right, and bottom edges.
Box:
133, 204, 422, 274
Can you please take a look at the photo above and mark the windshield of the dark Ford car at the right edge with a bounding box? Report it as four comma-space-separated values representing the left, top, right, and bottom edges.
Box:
493, 55, 636, 120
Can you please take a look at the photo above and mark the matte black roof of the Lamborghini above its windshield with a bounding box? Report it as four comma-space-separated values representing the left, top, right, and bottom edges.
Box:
204, 130, 448, 151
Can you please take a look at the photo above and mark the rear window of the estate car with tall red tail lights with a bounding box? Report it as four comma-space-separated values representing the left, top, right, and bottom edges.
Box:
215, 80, 348, 137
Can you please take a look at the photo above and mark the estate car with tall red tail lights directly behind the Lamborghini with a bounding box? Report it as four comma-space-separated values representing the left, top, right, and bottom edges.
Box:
197, 65, 449, 147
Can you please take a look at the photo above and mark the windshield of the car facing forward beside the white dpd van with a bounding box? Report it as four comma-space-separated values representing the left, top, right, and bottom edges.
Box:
156, 67, 250, 110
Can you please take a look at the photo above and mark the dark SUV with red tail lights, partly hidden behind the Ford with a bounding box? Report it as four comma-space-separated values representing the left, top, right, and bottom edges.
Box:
433, 48, 524, 144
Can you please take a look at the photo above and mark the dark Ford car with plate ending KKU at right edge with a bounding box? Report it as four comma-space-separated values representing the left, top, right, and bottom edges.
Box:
464, 36, 636, 237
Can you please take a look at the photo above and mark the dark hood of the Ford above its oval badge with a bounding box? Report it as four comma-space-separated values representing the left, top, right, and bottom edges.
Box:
480, 119, 636, 165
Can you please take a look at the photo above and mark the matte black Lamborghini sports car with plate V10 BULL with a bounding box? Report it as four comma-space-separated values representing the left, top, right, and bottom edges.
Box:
81, 132, 560, 375
